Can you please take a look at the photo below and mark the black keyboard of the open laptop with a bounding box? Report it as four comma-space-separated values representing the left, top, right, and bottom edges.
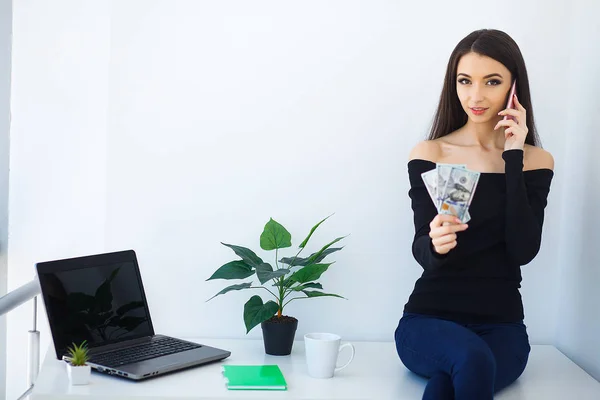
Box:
90, 336, 202, 368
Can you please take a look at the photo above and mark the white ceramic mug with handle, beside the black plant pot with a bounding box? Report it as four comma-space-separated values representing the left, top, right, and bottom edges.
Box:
304, 333, 354, 378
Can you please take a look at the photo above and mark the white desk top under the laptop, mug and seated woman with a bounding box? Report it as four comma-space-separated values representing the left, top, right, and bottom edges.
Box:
31, 339, 600, 400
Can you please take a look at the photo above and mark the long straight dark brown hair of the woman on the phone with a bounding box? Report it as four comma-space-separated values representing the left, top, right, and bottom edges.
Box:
428, 29, 540, 146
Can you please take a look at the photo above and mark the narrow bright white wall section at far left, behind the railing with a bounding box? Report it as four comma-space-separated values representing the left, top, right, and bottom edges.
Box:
7, 0, 110, 399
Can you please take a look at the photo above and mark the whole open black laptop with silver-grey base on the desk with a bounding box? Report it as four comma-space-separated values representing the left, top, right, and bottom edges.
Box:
36, 250, 231, 380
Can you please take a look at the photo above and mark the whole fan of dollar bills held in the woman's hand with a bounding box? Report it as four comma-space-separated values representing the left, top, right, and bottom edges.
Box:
421, 164, 480, 223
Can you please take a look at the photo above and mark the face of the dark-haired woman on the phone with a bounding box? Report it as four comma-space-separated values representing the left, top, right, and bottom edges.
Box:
456, 53, 512, 123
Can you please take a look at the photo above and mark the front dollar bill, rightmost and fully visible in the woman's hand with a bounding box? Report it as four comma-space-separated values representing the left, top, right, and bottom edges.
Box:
438, 167, 480, 221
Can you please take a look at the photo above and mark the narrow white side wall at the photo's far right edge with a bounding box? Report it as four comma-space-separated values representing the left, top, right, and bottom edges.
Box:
557, 0, 600, 380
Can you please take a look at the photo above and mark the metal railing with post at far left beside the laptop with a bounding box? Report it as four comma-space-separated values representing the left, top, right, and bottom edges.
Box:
0, 278, 40, 400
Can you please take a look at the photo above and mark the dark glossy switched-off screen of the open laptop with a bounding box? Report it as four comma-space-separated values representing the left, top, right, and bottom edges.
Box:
38, 261, 153, 356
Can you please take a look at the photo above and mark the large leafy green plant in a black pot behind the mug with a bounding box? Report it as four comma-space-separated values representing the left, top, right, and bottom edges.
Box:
207, 215, 345, 355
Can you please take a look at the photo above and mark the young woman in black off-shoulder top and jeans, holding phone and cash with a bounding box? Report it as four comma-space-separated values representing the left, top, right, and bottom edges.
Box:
395, 29, 554, 400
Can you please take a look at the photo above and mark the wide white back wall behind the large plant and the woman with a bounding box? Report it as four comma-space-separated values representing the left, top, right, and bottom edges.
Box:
106, 1, 568, 343
